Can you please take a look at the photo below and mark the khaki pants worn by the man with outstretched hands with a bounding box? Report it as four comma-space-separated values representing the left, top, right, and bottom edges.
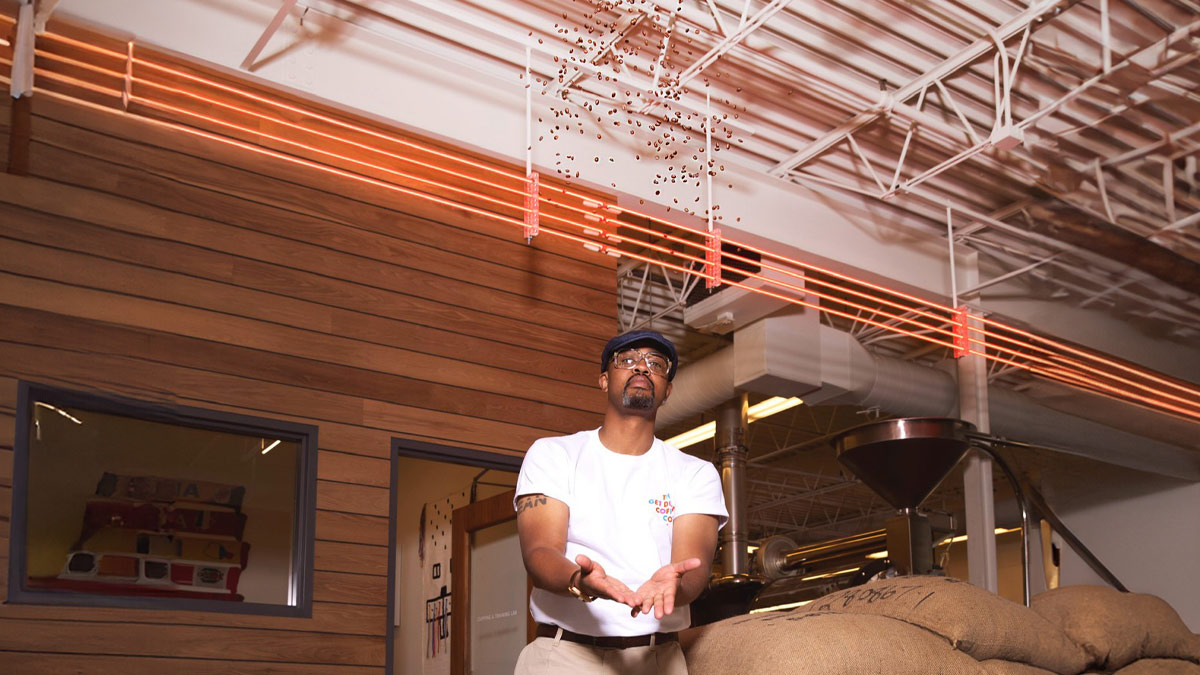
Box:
514, 638, 688, 675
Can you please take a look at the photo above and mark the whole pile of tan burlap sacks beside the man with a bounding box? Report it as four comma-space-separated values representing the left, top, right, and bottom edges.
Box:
684, 577, 1200, 675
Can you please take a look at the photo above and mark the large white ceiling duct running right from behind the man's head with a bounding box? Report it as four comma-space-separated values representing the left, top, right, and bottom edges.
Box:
658, 311, 1200, 480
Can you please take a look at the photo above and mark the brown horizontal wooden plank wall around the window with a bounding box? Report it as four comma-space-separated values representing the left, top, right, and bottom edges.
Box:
0, 23, 617, 675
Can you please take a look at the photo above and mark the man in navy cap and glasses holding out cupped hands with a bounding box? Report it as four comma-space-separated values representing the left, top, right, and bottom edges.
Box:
516, 330, 728, 675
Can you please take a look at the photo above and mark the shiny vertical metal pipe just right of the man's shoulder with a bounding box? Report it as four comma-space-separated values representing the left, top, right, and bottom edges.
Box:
715, 393, 750, 577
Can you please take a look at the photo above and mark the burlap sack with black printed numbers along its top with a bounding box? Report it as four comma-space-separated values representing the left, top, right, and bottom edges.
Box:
797, 577, 1090, 675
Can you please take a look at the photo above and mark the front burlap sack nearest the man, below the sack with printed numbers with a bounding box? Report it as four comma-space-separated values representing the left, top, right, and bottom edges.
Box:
685, 611, 985, 675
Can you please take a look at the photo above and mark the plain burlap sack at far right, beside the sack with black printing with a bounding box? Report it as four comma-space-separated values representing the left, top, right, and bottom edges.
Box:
1030, 586, 1200, 670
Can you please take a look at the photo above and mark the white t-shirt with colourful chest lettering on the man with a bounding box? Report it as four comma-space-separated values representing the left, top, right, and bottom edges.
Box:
516, 429, 728, 635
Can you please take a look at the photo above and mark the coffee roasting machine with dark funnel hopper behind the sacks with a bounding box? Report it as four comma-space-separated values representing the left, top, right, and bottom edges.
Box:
700, 417, 1124, 619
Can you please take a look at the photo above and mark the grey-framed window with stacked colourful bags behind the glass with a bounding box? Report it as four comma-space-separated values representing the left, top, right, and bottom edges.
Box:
8, 382, 317, 616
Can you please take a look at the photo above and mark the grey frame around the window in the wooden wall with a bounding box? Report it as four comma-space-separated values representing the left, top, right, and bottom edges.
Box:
7, 381, 318, 619
